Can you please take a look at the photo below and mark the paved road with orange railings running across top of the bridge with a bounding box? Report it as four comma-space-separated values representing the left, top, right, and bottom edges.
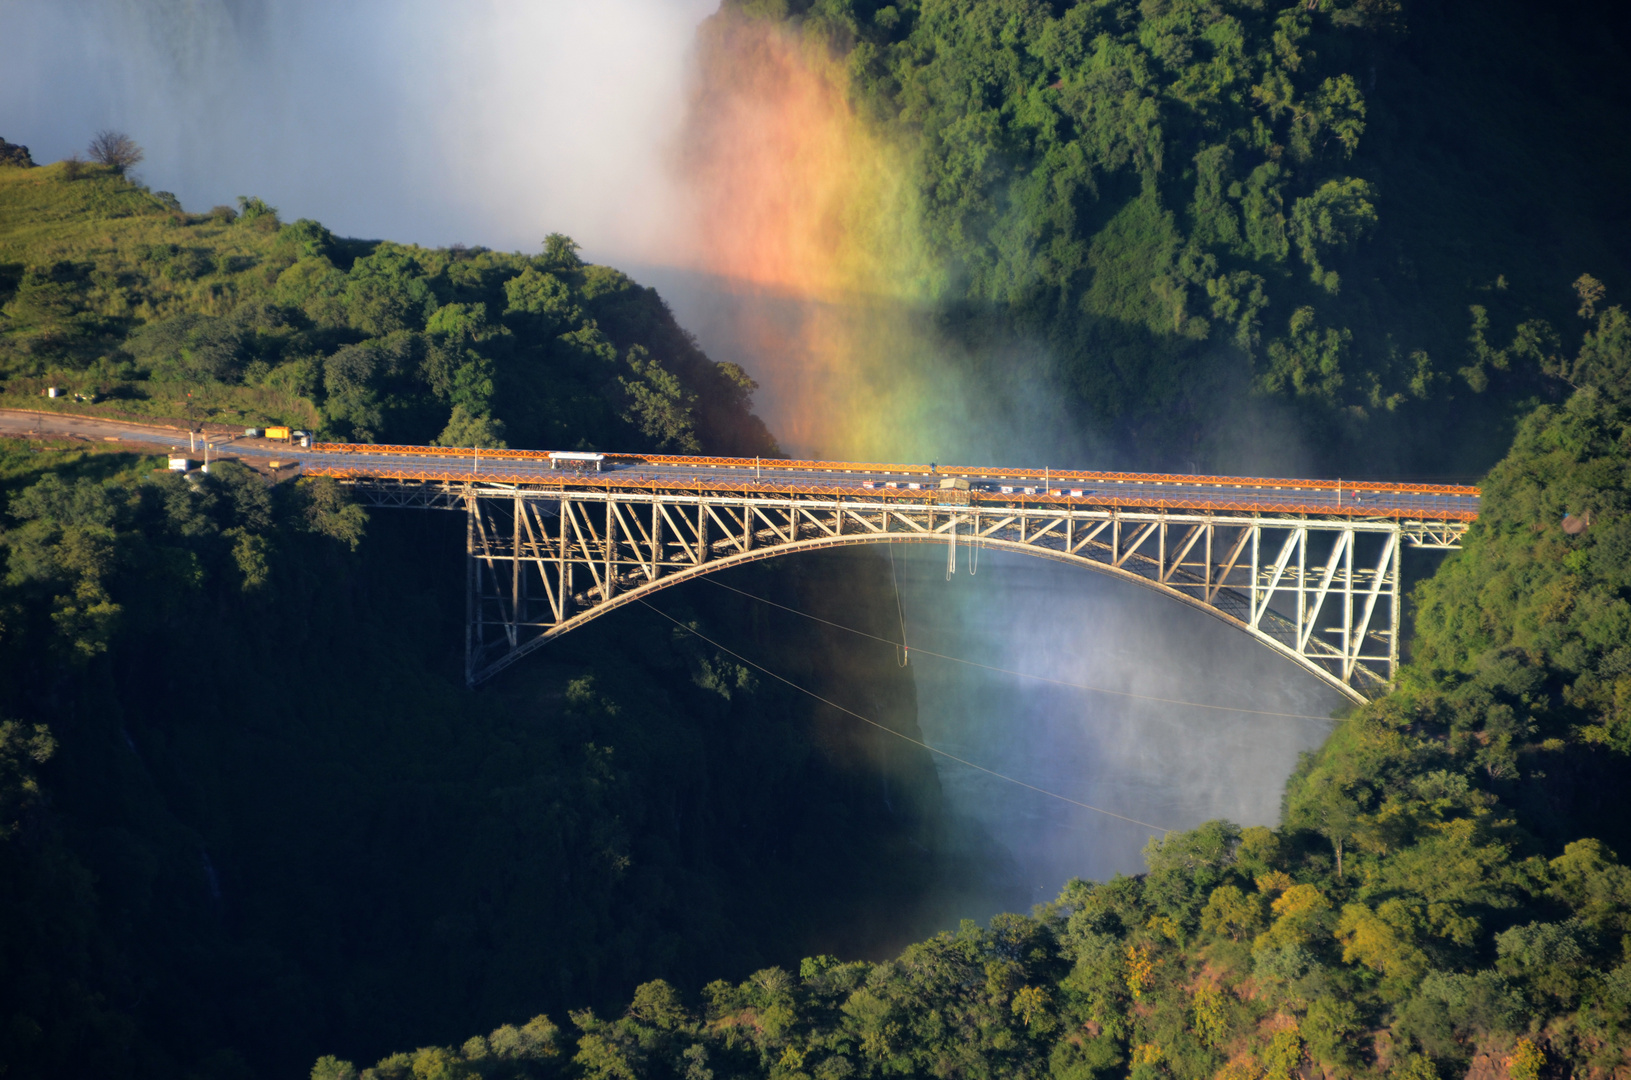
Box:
0, 409, 1479, 520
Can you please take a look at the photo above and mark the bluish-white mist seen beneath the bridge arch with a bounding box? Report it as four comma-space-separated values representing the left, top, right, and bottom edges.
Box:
897, 545, 1342, 914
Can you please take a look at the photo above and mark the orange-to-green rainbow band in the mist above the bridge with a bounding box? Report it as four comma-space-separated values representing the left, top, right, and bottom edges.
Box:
674, 13, 991, 460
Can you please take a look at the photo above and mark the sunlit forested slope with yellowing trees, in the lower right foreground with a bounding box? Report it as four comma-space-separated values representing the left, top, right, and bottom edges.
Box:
312, 292, 1631, 1080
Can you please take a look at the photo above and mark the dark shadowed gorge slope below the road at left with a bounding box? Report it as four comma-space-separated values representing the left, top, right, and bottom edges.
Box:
0, 442, 948, 1077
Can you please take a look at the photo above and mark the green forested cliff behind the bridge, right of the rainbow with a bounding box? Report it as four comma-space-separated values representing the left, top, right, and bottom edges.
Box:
716, 0, 1631, 473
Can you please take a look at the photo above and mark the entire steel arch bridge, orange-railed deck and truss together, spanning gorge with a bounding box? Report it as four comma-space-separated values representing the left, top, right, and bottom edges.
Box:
279, 444, 1479, 702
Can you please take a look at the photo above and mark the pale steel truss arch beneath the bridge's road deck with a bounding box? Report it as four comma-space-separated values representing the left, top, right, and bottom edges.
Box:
340, 480, 1466, 702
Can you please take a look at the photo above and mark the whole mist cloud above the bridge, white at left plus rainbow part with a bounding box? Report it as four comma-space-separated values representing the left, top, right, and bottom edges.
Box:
0, 0, 1065, 460
